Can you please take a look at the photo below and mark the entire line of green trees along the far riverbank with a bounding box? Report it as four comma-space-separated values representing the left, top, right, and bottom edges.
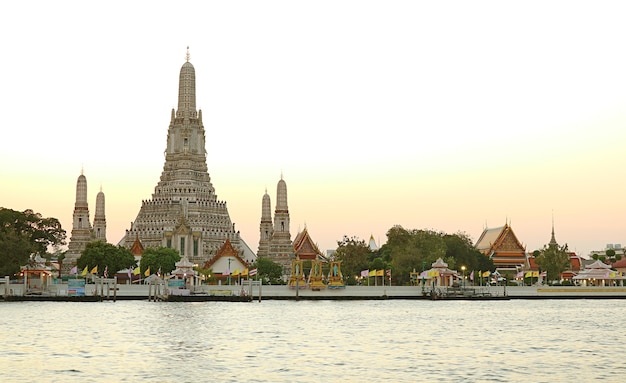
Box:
0, 208, 569, 285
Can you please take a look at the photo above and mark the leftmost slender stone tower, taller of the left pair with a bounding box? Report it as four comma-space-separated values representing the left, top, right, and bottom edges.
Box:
63, 171, 94, 273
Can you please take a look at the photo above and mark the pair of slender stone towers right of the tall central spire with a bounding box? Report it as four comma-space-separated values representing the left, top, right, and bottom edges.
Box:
257, 175, 296, 275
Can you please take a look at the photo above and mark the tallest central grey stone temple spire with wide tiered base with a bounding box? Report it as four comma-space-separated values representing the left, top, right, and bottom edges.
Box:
120, 50, 255, 265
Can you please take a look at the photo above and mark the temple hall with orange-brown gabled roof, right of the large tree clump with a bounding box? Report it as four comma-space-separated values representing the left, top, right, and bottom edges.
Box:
476, 223, 528, 271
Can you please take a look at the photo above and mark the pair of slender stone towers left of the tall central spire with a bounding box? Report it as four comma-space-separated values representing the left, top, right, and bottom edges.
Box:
62, 172, 106, 274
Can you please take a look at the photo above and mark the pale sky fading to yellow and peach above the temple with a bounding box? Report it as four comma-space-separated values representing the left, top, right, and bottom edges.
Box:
0, 0, 626, 256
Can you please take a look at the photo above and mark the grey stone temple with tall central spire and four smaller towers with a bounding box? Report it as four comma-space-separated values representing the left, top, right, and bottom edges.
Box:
63, 51, 310, 272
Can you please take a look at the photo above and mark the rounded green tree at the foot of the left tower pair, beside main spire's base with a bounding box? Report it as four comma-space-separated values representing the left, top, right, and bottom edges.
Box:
76, 241, 136, 276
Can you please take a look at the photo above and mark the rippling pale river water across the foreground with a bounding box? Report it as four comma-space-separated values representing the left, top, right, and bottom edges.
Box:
0, 299, 626, 382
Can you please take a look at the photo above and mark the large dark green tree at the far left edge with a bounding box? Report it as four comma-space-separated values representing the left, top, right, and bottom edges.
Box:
0, 208, 66, 276
